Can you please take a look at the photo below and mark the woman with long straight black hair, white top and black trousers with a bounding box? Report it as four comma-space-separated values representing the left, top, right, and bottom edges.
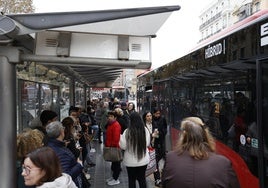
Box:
119, 112, 150, 188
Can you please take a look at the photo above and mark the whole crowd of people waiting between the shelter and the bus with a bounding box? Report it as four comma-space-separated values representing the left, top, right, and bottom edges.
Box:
17, 97, 239, 188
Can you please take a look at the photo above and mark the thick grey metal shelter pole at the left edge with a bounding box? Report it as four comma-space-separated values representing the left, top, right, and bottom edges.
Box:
0, 55, 17, 187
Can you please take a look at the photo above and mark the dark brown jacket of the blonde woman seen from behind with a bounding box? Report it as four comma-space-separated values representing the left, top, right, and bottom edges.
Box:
162, 151, 240, 188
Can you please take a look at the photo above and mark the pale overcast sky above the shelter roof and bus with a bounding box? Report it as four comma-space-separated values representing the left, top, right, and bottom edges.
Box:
33, 0, 213, 69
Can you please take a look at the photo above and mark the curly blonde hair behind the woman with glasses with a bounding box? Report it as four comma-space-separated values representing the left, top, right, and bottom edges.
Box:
17, 129, 44, 160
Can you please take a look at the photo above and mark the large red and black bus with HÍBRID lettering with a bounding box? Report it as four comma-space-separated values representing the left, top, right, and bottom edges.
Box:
137, 10, 268, 188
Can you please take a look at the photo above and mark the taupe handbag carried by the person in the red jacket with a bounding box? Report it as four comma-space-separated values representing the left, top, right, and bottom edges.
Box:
103, 147, 123, 162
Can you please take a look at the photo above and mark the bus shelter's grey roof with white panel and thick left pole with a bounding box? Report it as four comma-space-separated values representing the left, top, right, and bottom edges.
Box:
0, 6, 180, 187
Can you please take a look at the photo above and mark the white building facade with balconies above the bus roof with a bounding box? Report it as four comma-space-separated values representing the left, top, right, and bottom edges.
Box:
199, 0, 268, 42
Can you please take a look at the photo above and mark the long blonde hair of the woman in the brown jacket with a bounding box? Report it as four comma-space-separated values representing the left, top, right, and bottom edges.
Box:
176, 117, 215, 160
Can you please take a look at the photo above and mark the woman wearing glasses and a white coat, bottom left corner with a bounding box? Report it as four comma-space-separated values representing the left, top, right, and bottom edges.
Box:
22, 147, 77, 188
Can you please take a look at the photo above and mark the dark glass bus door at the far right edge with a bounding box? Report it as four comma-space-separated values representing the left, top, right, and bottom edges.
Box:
255, 59, 268, 188
